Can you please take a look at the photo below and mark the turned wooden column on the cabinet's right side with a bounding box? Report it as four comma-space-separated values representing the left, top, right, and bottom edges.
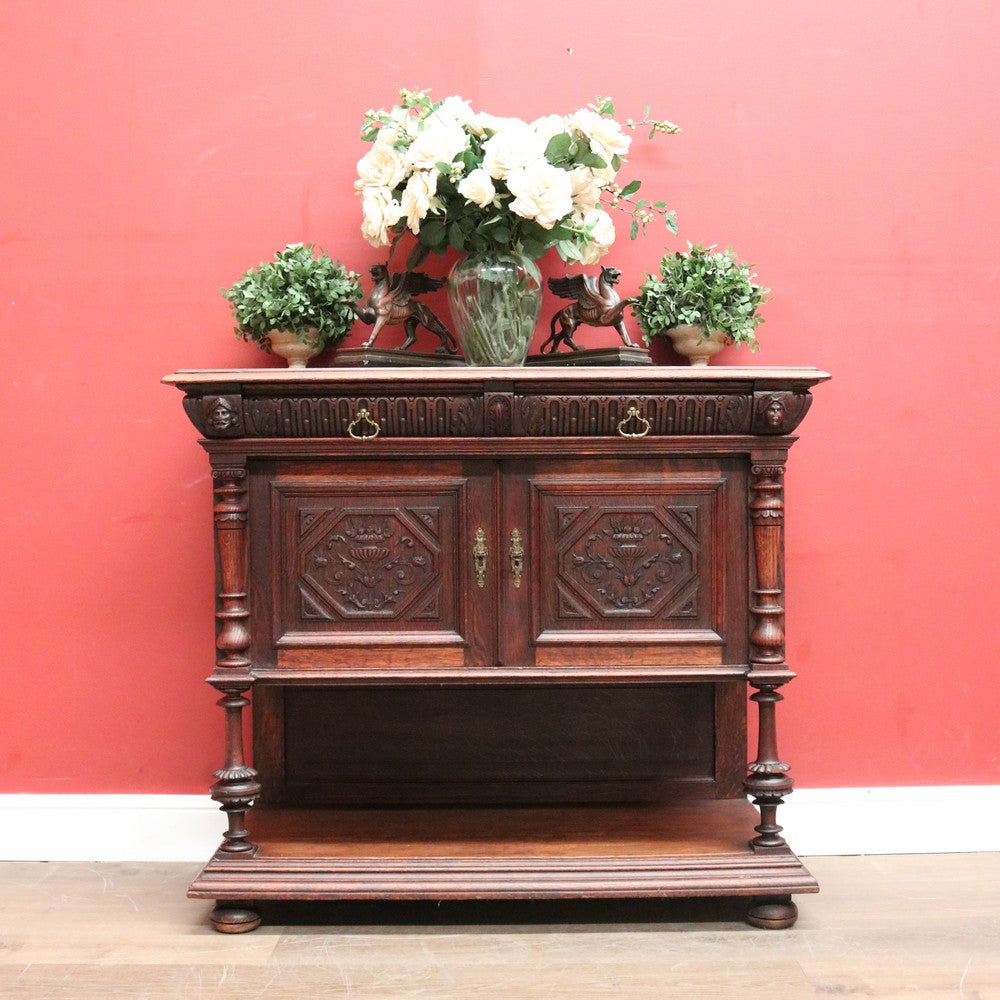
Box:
744, 451, 795, 851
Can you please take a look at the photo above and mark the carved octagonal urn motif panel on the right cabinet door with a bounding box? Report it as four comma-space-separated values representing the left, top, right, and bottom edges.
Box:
557, 507, 700, 618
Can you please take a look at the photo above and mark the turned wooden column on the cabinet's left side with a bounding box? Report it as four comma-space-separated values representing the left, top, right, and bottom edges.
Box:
208, 457, 260, 855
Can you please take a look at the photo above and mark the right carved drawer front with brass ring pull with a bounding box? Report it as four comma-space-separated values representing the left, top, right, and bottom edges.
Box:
514, 394, 752, 437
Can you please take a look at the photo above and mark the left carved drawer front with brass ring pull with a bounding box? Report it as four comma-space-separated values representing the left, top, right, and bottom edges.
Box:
243, 395, 483, 440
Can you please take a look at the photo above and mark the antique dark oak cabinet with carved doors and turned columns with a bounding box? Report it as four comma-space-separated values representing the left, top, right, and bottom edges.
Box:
166, 367, 828, 932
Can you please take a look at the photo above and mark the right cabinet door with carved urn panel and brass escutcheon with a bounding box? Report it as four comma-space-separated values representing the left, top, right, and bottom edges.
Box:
500, 459, 747, 672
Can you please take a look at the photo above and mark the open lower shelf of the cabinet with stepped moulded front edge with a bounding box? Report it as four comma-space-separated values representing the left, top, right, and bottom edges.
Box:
188, 799, 819, 901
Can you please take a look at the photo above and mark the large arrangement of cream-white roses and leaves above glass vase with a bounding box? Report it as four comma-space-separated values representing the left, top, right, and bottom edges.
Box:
355, 90, 679, 267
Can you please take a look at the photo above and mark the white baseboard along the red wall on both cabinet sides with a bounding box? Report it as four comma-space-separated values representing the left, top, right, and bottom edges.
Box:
0, 785, 1000, 861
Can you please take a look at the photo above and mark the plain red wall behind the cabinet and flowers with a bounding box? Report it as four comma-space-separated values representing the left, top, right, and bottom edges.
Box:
0, 0, 1000, 792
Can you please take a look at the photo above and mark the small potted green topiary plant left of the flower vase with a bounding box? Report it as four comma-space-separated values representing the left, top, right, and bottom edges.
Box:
222, 243, 361, 368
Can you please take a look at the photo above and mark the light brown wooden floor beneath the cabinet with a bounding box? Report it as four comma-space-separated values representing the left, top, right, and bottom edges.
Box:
0, 854, 1000, 1000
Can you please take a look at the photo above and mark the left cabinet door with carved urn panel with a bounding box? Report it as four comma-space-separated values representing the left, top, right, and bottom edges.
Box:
258, 461, 496, 671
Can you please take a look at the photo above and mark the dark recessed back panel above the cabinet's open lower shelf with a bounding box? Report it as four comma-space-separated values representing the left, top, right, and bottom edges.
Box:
270, 684, 719, 806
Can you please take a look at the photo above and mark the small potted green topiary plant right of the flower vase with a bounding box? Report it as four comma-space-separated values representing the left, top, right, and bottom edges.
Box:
632, 243, 770, 365
